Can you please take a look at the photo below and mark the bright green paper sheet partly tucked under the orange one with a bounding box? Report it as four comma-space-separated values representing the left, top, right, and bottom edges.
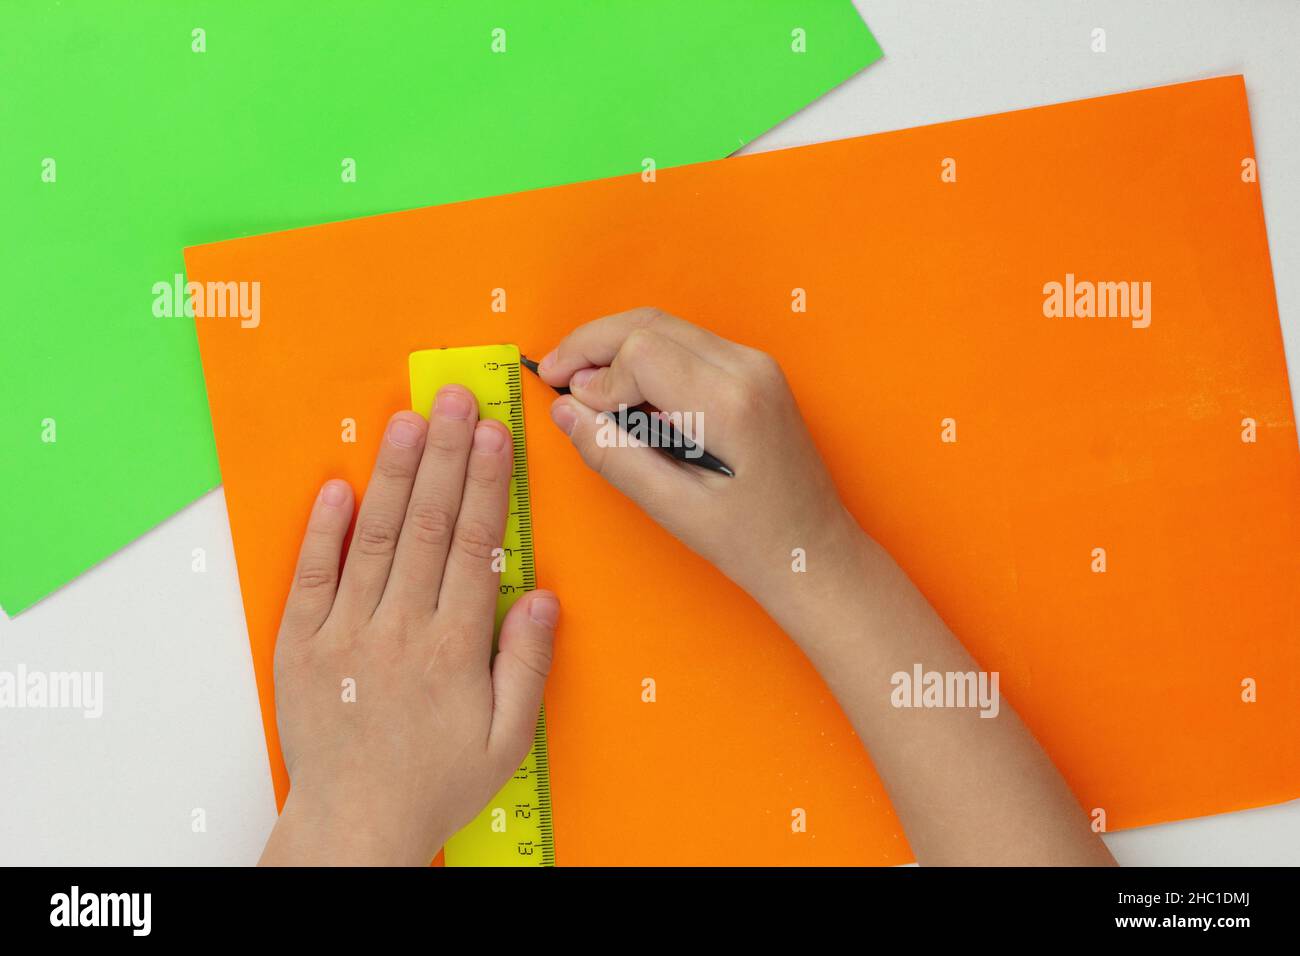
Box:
0, 0, 880, 614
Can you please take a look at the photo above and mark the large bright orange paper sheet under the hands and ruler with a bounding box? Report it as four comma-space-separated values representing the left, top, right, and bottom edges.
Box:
186, 77, 1300, 865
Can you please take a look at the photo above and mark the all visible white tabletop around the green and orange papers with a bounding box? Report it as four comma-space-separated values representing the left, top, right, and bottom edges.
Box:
0, 0, 1300, 865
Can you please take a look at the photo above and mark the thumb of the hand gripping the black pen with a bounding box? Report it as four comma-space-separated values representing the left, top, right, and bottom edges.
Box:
551, 395, 707, 520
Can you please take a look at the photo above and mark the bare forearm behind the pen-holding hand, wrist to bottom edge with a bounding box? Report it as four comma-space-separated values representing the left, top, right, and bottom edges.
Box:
764, 515, 1114, 865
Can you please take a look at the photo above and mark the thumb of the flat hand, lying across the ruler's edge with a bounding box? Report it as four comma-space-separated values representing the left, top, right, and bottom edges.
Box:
488, 591, 560, 770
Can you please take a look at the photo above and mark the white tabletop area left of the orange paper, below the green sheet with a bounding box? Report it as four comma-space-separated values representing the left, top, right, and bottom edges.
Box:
0, 494, 276, 865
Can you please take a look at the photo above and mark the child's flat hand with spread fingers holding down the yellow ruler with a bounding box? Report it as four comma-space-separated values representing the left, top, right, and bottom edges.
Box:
263, 386, 559, 865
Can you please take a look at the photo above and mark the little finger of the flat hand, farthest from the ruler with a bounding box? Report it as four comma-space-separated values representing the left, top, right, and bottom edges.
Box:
282, 480, 352, 636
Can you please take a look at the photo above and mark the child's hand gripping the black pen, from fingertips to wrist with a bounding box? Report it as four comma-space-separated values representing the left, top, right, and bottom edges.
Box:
538, 308, 863, 616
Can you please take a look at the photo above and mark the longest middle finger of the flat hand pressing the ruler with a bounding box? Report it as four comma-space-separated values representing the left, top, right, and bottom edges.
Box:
384, 385, 478, 611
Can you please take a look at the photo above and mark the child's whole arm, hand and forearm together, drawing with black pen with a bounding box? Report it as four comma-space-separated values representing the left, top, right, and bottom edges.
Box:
538, 308, 1114, 865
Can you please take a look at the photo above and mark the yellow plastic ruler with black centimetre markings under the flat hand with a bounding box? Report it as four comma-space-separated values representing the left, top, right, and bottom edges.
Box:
411, 345, 555, 866
